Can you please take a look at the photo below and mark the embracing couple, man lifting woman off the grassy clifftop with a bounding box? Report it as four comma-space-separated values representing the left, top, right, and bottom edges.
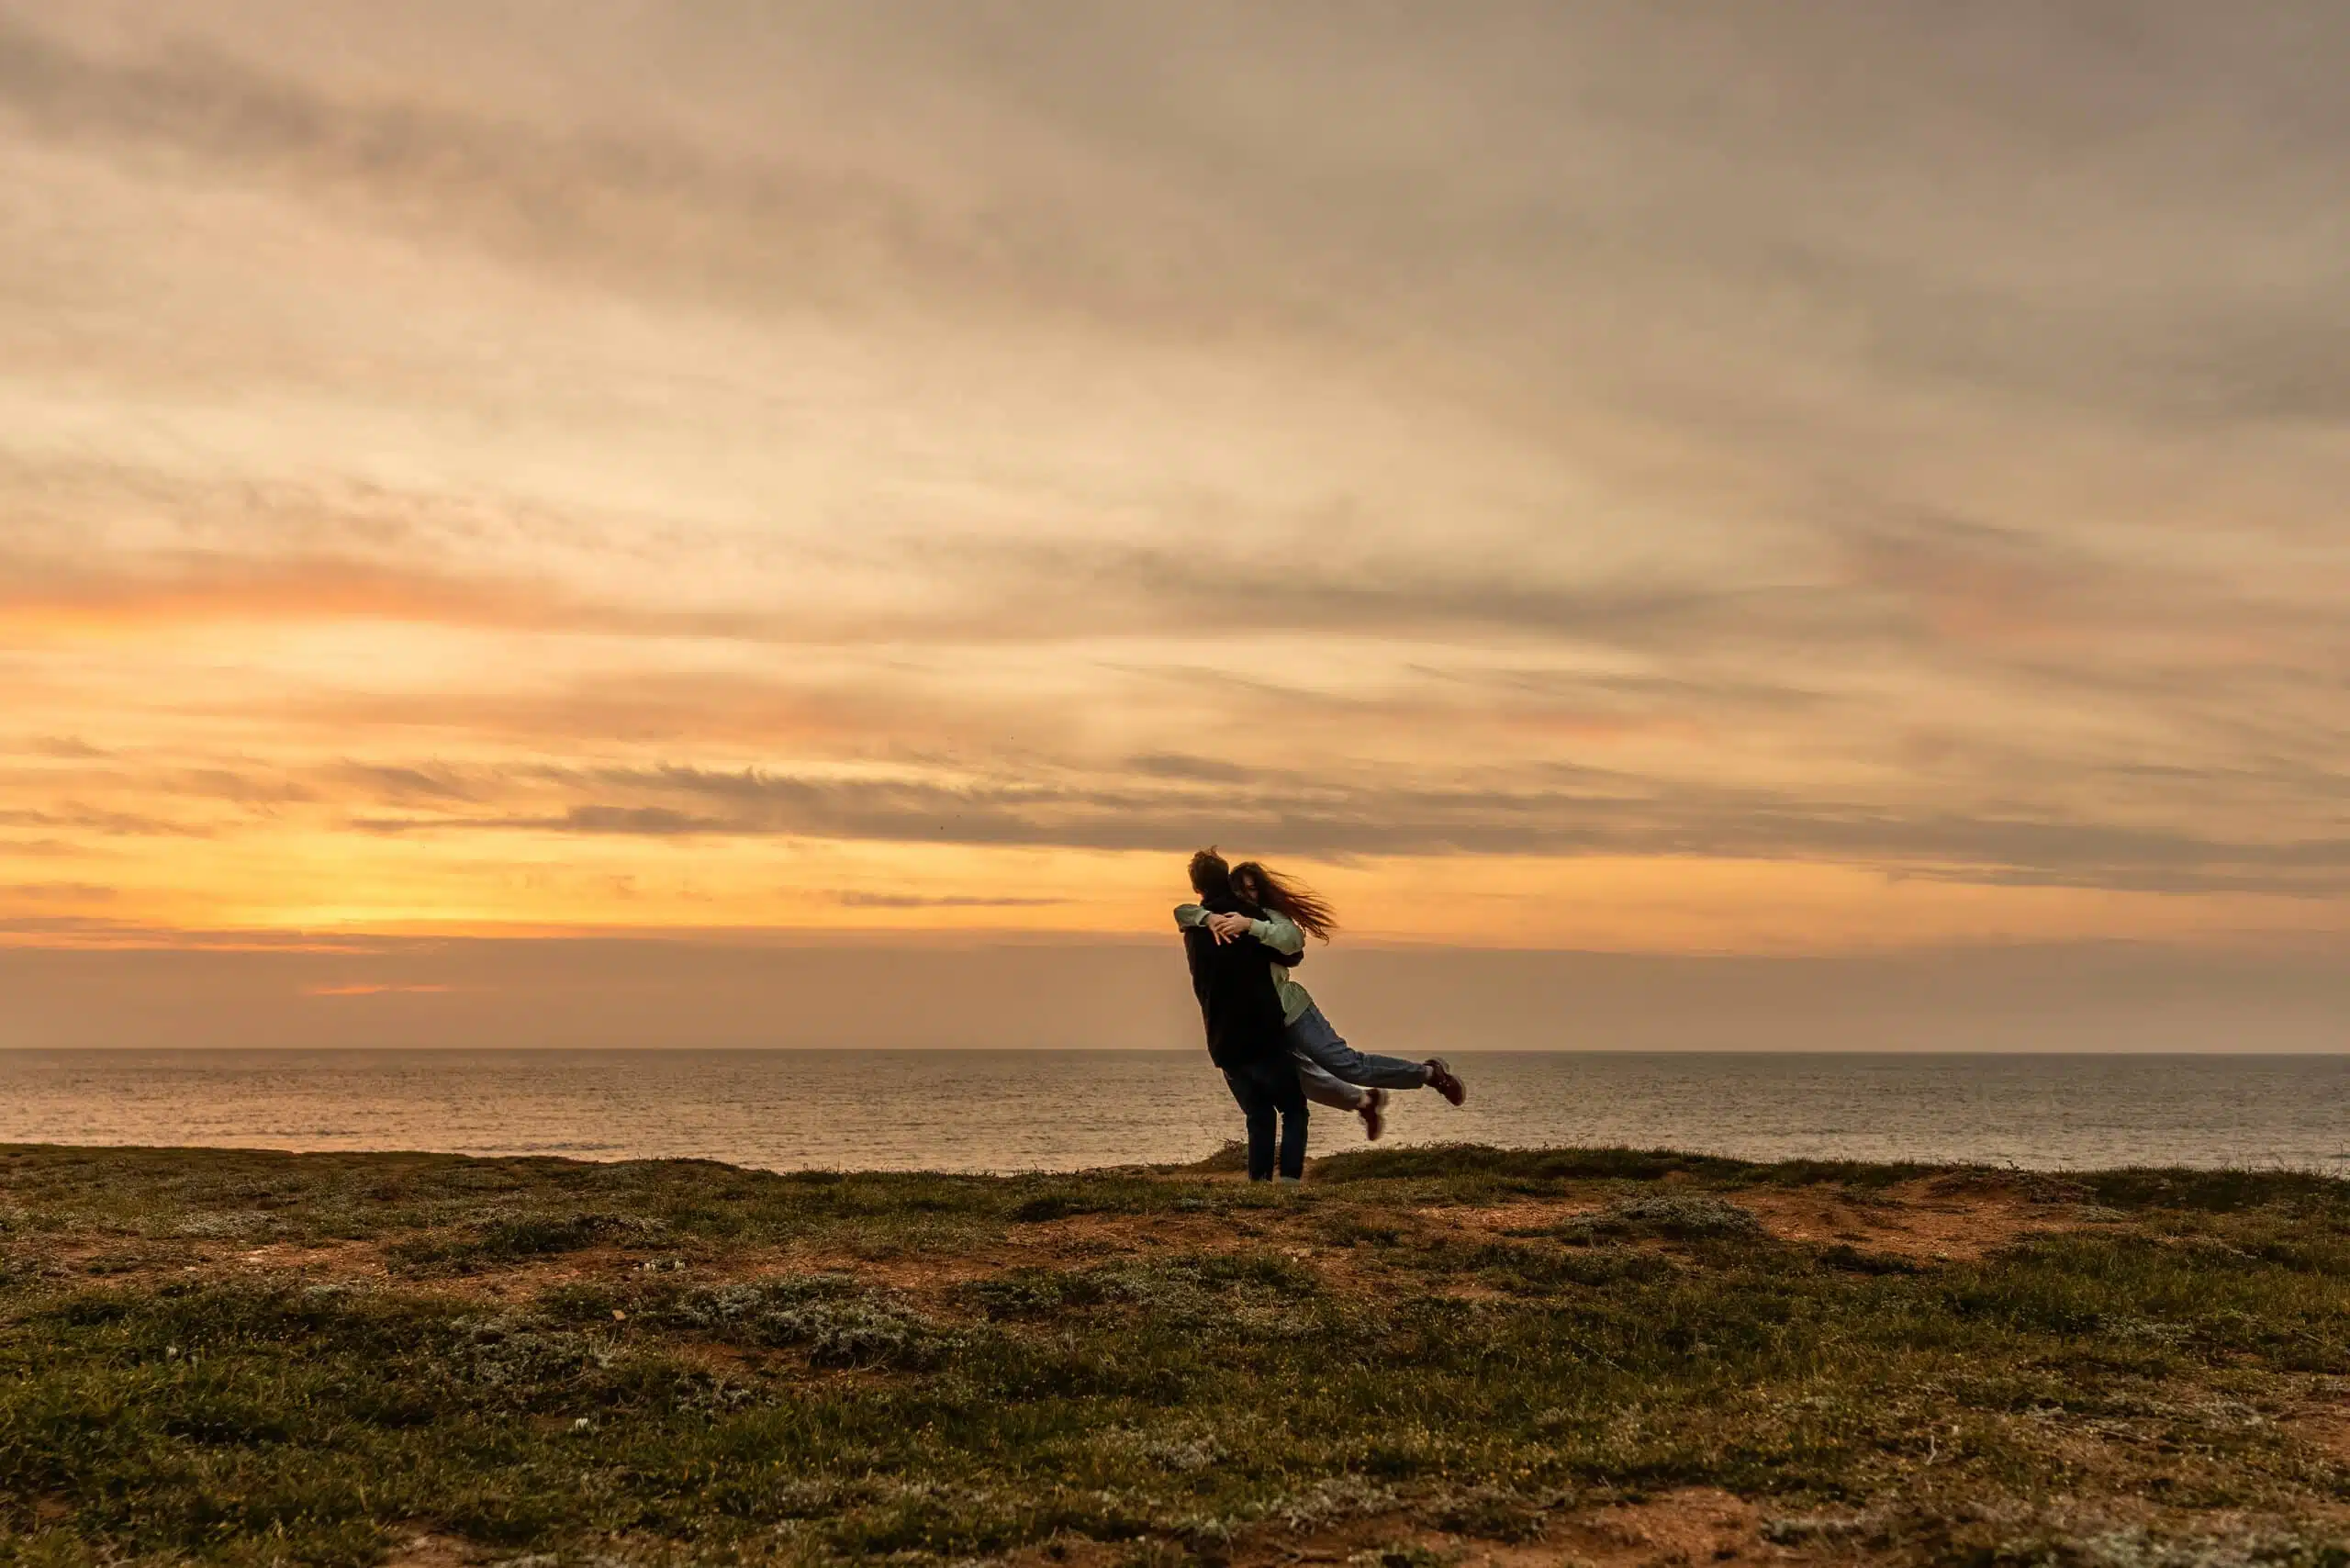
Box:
1175, 848, 1469, 1182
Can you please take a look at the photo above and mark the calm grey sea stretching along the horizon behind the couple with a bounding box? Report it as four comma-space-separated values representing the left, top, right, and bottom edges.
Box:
0, 1051, 2350, 1173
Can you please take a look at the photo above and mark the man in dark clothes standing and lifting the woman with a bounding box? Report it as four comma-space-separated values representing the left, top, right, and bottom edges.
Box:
1182, 848, 1306, 1182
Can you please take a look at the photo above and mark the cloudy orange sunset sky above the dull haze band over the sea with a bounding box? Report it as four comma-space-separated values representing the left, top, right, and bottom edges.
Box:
0, 0, 2350, 1047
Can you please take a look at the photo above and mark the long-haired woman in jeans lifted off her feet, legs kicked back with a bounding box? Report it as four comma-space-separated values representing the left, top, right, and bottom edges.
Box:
1175, 860, 1469, 1137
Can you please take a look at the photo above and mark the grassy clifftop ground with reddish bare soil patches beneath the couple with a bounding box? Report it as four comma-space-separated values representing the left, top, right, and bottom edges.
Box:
0, 1148, 2350, 1568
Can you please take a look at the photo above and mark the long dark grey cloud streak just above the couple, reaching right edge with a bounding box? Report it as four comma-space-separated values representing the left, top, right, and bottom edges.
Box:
312, 767, 2350, 907
